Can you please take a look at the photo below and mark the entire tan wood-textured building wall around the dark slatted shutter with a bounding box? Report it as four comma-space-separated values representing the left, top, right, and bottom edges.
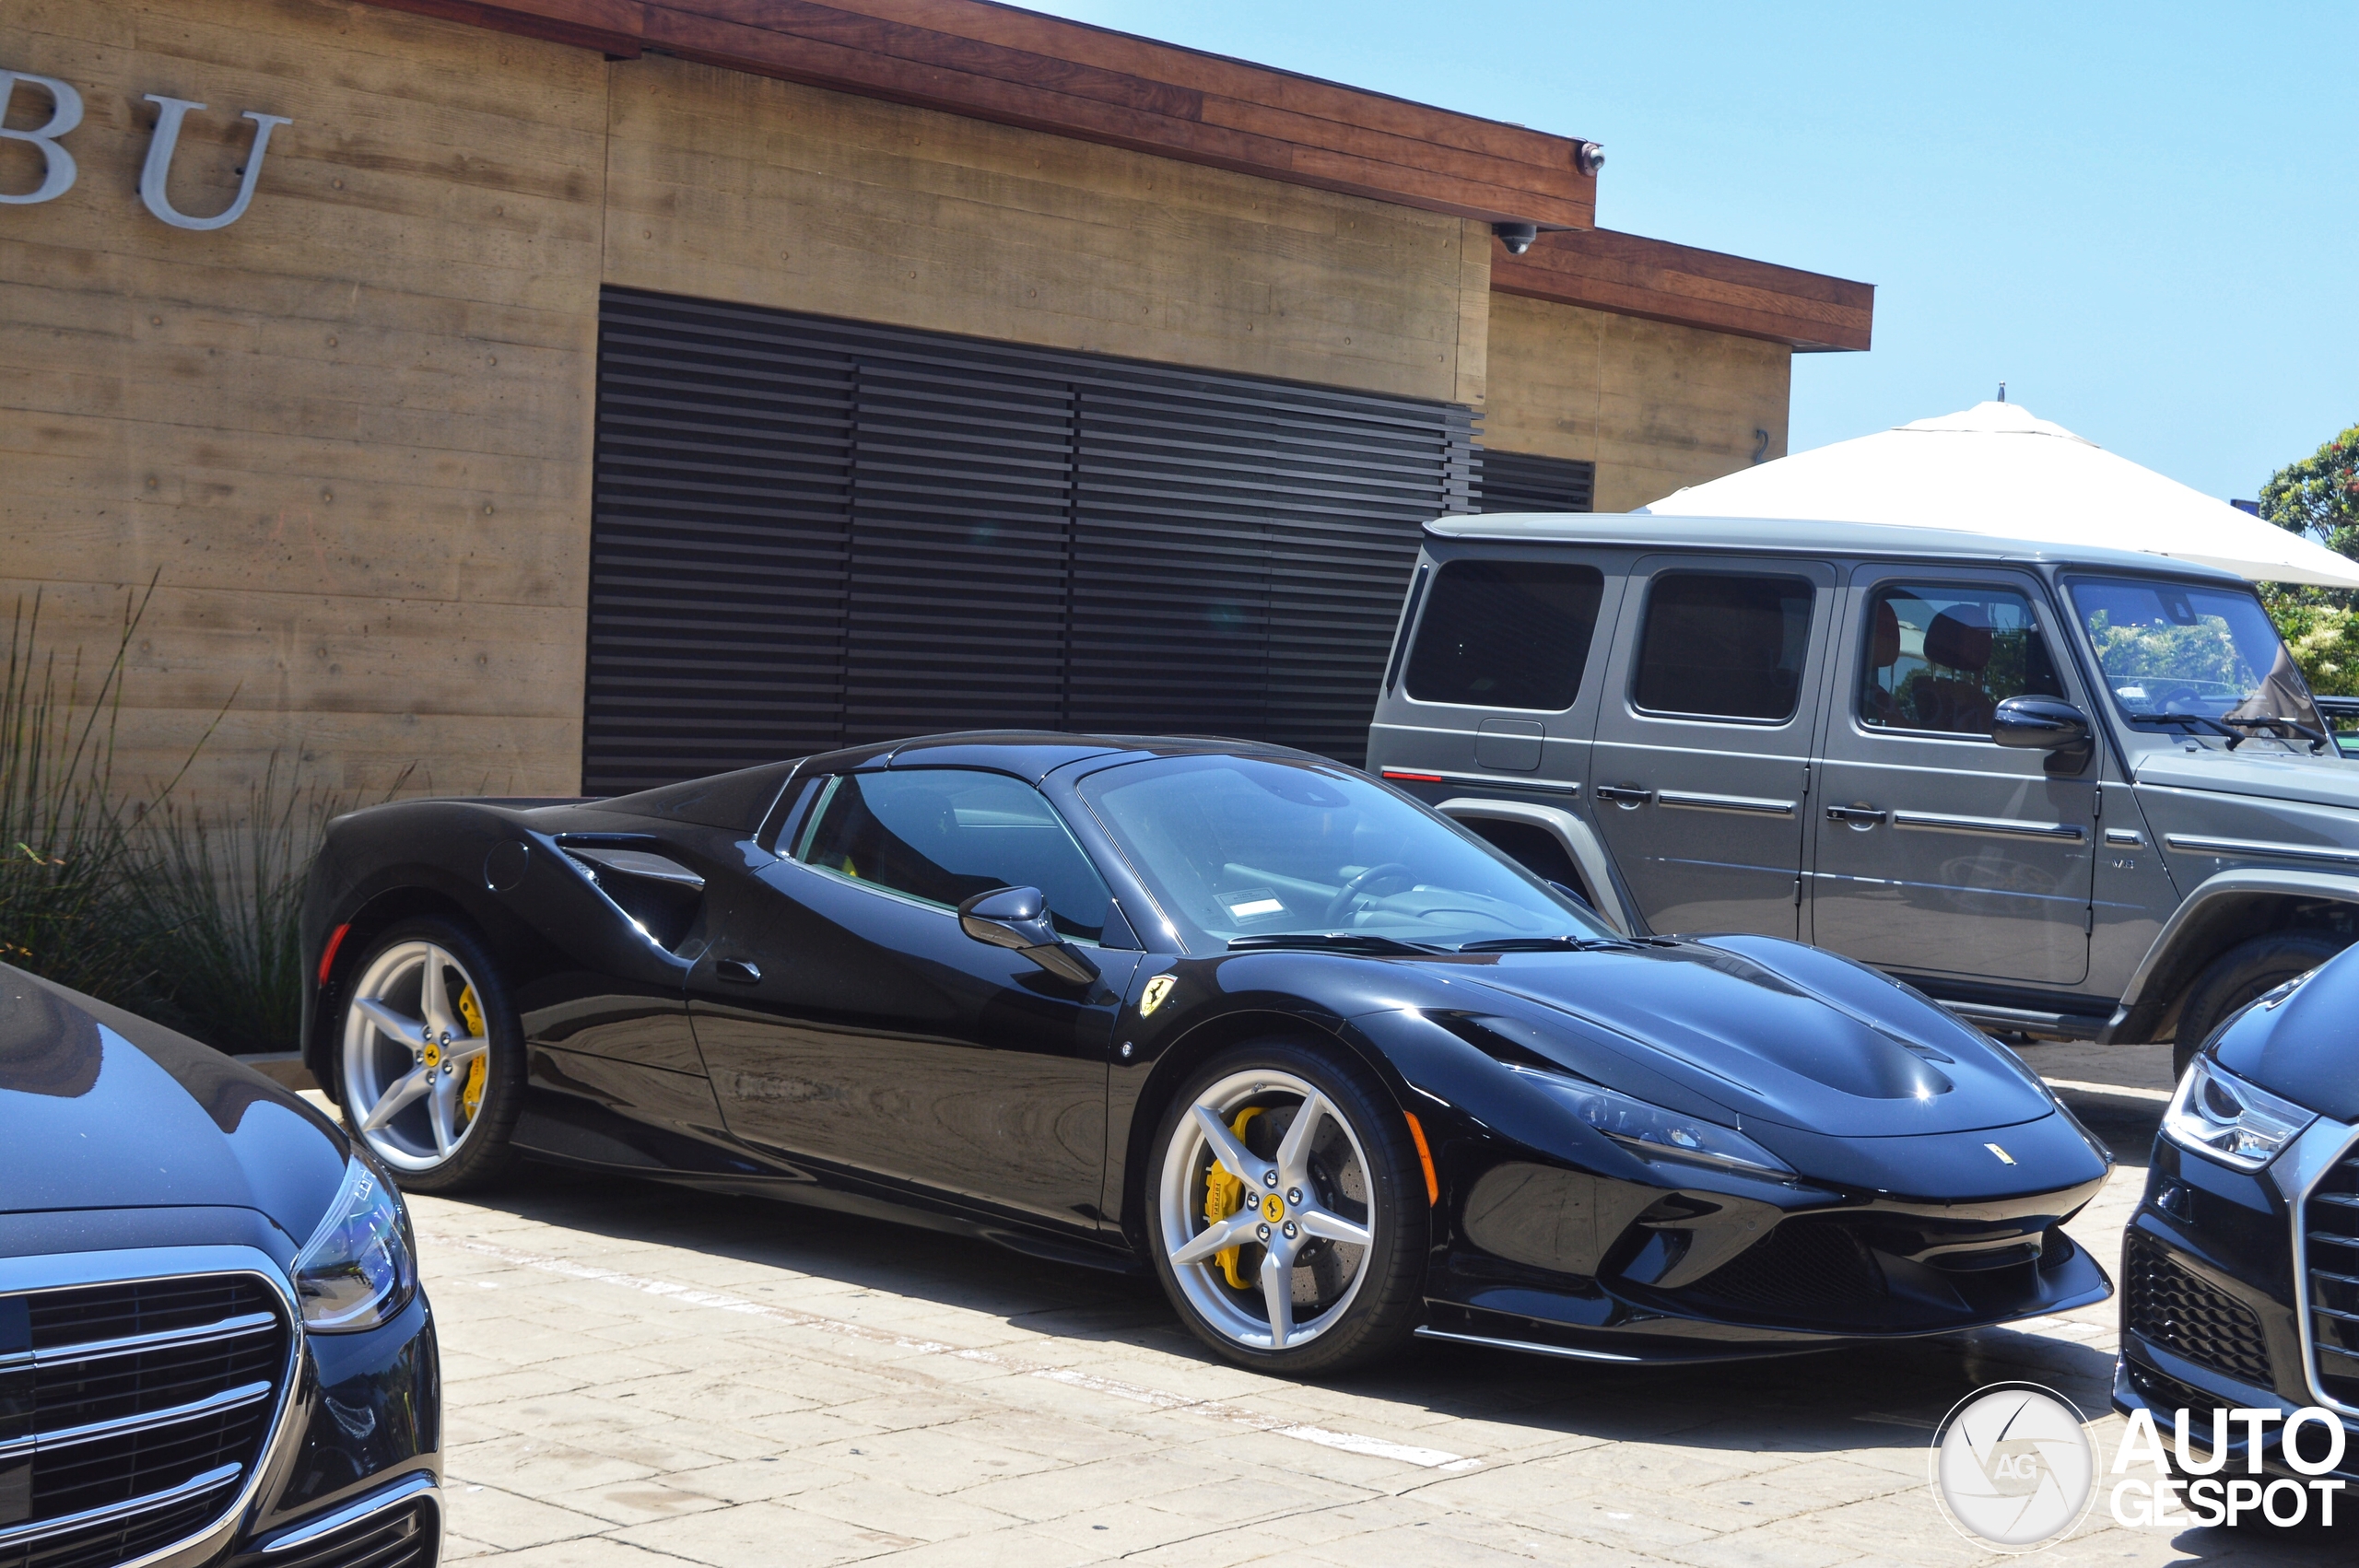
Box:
0, 0, 1786, 795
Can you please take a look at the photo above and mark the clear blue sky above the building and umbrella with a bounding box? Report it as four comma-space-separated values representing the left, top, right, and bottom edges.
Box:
1036, 0, 2359, 497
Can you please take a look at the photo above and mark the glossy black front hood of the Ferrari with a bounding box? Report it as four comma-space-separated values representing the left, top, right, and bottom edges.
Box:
1450, 936, 2055, 1137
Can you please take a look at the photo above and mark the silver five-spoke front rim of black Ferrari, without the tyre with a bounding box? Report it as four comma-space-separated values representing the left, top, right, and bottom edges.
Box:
1156, 1068, 1385, 1352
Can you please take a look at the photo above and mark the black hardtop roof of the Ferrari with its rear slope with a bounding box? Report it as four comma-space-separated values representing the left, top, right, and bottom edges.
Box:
582, 729, 1332, 830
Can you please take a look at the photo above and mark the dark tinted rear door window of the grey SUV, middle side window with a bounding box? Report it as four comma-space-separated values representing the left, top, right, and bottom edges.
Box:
1630, 570, 1812, 724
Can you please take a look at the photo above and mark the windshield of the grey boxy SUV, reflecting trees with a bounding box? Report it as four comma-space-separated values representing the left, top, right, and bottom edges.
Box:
2071, 578, 2324, 741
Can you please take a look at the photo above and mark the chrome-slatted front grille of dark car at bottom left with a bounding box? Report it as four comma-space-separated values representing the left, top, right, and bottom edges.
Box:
0, 1273, 290, 1568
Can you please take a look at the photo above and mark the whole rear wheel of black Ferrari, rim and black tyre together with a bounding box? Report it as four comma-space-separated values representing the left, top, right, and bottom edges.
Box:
337, 919, 523, 1193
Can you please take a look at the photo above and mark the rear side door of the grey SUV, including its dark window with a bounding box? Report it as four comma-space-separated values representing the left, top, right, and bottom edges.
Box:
1590, 556, 1836, 936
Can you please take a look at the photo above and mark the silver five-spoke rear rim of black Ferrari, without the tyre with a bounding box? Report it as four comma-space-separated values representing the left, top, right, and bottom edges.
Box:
342, 941, 490, 1172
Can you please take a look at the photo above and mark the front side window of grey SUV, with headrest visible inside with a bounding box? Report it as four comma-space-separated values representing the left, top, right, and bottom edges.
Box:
1859, 582, 2064, 738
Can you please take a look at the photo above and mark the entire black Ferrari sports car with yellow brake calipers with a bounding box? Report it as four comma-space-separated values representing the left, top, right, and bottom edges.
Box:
304, 733, 2109, 1370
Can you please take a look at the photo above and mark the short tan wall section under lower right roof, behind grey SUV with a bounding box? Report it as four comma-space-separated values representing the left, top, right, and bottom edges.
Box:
1484, 295, 1793, 511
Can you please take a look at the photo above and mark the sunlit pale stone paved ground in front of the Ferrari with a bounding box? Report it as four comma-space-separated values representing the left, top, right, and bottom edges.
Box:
358, 1047, 2359, 1568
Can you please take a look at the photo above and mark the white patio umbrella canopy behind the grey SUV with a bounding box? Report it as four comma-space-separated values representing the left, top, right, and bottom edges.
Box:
1639, 404, 2359, 587
